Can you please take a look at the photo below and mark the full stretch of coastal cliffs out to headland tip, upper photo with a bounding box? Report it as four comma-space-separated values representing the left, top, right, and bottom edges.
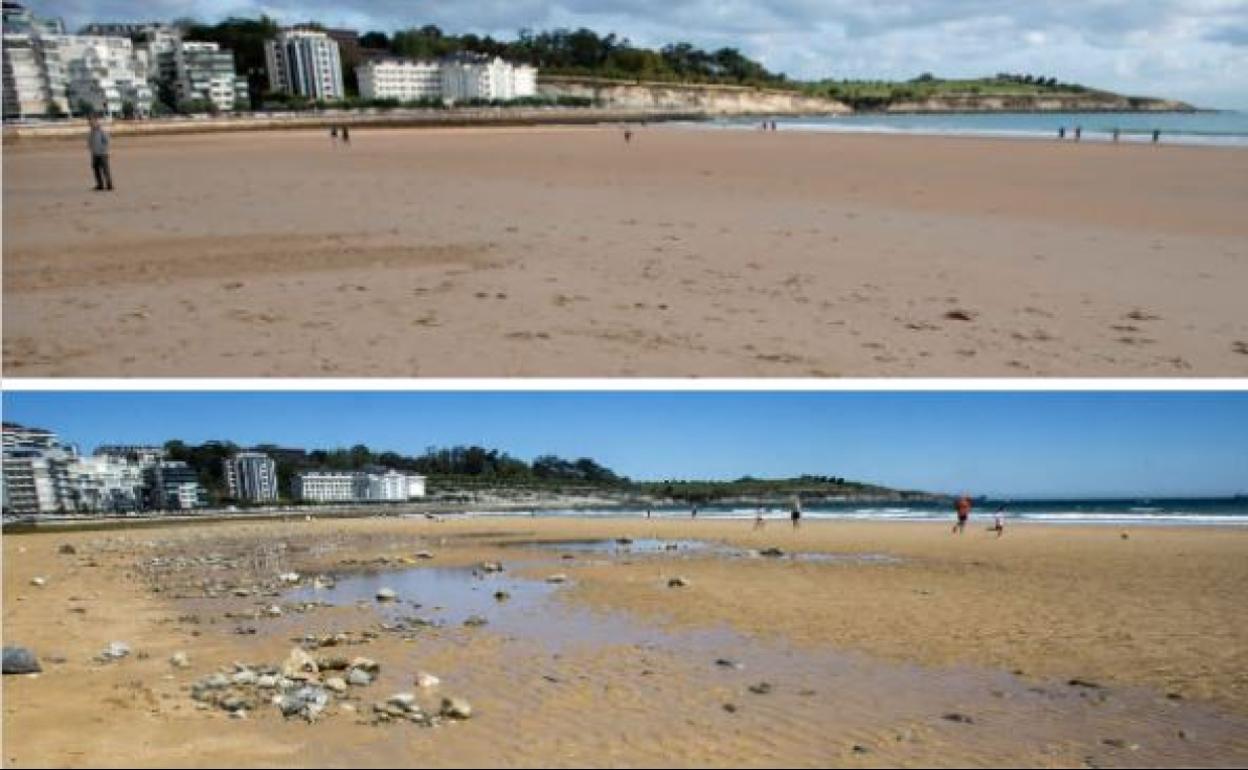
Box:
538, 76, 1193, 115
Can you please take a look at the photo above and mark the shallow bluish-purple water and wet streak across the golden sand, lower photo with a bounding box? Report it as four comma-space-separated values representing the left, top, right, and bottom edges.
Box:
285, 556, 1248, 766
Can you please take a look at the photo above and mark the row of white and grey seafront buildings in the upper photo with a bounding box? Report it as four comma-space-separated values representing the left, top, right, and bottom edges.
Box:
2, 0, 537, 120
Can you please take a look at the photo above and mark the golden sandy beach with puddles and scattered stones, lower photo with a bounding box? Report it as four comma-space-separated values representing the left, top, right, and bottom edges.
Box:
4, 517, 1248, 768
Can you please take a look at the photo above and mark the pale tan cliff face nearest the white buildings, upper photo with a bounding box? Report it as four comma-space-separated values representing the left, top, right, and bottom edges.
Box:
538, 77, 851, 115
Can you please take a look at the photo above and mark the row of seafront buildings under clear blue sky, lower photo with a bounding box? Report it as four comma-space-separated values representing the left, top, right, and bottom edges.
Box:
0, 423, 426, 514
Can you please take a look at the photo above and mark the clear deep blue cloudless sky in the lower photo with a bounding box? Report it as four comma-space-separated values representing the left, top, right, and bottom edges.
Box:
4, 392, 1248, 497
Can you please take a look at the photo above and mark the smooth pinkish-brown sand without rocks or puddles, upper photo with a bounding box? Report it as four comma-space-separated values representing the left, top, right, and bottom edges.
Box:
4, 127, 1248, 377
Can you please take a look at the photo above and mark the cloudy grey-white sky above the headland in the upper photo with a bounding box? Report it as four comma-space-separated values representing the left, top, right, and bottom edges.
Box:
29, 0, 1248, 109
